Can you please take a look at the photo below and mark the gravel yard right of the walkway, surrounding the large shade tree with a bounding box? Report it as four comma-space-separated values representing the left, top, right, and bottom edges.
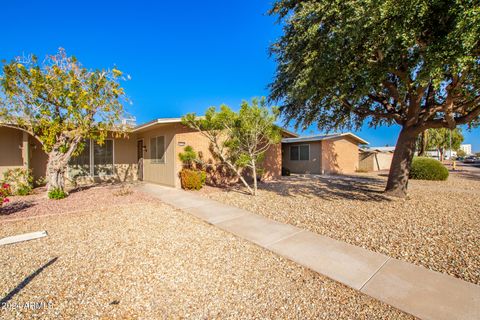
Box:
201, 172, 480, 284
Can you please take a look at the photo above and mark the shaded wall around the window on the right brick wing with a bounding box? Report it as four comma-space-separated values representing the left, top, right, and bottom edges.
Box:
282, 141, 322, 174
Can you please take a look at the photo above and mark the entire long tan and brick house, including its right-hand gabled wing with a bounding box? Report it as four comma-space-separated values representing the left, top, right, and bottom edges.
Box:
0, 118, 366, 187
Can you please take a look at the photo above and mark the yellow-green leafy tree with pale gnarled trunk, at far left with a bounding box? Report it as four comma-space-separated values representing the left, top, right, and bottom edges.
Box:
0, 49, 126, 192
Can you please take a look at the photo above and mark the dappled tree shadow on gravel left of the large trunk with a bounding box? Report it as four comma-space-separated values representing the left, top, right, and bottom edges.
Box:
261, 175, 391, 202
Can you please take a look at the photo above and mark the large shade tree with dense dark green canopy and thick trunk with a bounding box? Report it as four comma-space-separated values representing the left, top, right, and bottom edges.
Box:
271, 0, 480, 196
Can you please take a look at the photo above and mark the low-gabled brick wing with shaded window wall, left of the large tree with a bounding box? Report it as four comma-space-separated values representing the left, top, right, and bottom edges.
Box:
282, 133, 368, 174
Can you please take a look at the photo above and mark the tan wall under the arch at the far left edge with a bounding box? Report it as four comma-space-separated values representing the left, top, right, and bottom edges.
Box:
0, 127, 23, 179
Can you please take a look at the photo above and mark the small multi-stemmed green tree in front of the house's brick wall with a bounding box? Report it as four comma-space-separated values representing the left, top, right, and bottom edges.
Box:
182, 98, 281, 195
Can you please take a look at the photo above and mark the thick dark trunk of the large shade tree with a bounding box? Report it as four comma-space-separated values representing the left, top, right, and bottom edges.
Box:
385, 127, 417, 198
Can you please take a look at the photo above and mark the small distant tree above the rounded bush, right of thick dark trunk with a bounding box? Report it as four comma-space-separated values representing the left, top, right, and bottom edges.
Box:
427, 128, 463, 161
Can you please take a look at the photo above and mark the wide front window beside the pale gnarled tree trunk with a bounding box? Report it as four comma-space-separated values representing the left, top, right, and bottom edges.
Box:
68, 139, 114, 178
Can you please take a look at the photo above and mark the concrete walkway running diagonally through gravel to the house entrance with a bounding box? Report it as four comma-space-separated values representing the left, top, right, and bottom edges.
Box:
139, 184, 480, 319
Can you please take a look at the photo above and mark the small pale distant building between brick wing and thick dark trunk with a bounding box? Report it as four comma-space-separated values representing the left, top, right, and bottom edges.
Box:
358, 147, 395, 171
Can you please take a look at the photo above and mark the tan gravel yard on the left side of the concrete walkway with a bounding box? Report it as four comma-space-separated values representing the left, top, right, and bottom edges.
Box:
0, 188, 411, 319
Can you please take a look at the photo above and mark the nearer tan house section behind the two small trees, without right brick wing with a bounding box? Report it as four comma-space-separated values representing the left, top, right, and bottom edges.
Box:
0, 118, 296, 187
